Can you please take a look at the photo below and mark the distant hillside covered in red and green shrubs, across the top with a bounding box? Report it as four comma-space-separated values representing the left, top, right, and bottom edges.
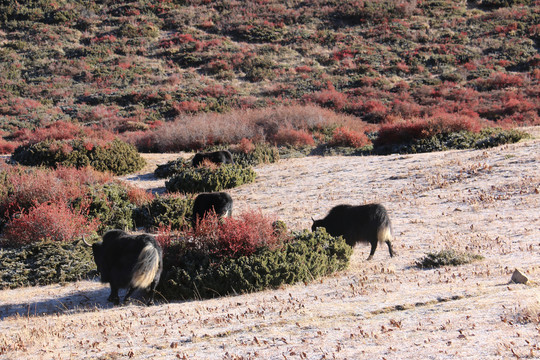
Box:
0, 0, 540, 138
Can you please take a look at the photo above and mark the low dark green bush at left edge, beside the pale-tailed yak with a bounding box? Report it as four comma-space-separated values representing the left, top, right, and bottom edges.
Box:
0, 241, 96, 289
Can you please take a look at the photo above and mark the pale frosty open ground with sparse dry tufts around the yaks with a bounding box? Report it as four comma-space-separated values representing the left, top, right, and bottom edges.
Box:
0, 128, 540, 359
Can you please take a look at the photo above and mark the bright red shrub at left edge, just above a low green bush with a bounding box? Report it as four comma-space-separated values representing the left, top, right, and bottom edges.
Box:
4, 203, 98, 246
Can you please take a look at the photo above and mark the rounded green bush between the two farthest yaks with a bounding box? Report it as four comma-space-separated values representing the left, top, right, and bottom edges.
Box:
165, 164, 257, 193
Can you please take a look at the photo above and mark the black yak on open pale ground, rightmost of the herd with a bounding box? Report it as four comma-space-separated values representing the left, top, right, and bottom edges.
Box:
311, 204, 394, 260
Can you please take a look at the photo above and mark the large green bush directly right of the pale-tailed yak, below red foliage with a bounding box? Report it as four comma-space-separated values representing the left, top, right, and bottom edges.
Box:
158, 229, 352, 300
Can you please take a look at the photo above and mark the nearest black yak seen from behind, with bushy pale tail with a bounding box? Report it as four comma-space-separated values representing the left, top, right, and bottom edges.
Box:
92, 230, 163, 305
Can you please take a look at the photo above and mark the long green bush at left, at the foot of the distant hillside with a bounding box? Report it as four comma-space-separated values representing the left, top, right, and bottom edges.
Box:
12, 139, 145, 175
